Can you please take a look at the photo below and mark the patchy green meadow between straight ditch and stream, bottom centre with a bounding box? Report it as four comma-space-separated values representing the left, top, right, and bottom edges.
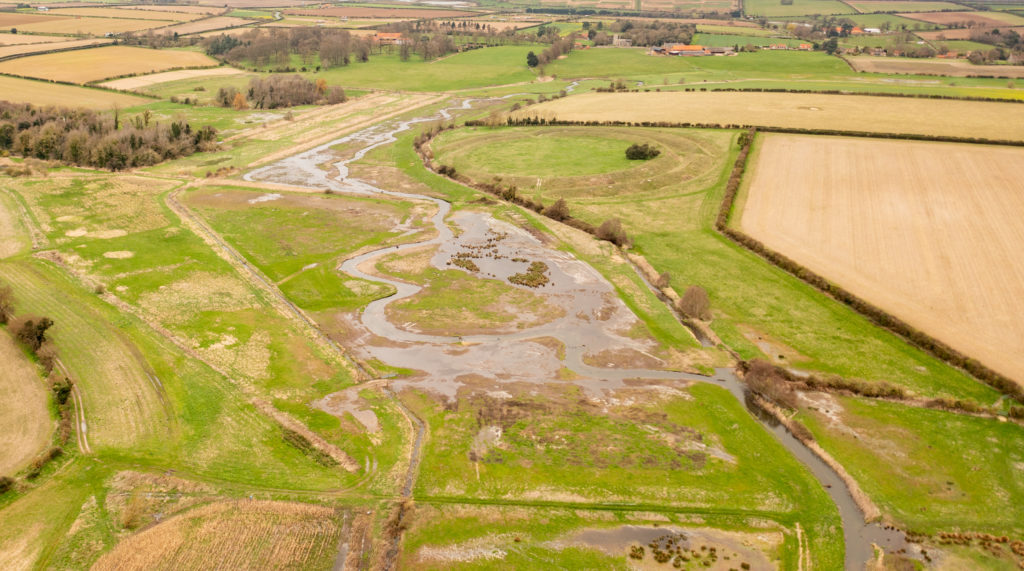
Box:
406, 385, 841, 567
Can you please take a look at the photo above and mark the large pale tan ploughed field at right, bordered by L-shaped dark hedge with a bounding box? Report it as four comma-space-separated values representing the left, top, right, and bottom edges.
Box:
740, 134, 1024, 383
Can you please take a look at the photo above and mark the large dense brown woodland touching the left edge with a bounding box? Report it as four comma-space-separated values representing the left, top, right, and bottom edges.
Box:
0, 101, 216, 171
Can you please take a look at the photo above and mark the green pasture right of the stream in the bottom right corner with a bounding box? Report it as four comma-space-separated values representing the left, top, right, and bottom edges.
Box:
800, 397, 1024, 537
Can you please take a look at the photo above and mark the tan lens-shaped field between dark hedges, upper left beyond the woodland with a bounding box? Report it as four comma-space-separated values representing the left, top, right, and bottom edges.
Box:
0, 46, 217, 83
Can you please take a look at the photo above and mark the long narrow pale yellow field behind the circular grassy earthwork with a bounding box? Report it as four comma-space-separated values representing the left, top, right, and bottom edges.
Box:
515, 91, 1024, 140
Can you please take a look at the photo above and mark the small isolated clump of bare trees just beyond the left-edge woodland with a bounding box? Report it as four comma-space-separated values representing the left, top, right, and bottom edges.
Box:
216, 74, 346, 111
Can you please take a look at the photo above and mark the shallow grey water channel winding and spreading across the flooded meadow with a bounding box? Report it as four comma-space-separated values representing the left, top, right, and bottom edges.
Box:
245, 100, 907, 569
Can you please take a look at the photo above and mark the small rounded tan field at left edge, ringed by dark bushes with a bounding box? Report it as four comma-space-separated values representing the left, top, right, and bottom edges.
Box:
0, 332, 53, 476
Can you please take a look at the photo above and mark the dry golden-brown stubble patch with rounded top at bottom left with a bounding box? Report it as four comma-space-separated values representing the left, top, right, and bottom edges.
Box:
93, 500, 342, 571
